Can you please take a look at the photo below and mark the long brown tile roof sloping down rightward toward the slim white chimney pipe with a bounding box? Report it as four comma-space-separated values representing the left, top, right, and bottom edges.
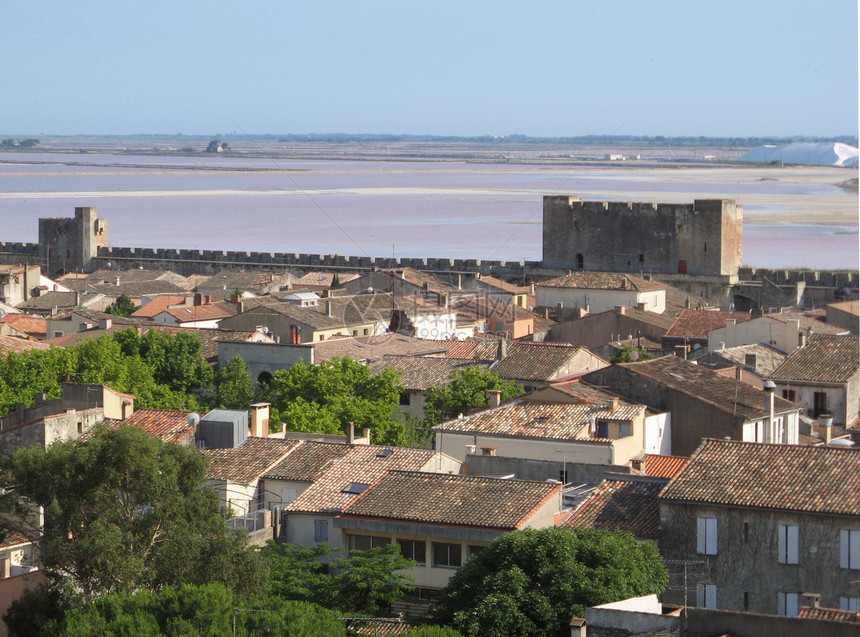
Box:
616, 356, 801, 419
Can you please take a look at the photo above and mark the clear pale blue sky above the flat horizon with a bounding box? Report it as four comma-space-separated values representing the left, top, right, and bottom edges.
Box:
0, 0, 858, 136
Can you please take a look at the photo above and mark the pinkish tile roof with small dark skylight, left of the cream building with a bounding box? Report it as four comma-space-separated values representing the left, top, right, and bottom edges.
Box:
285, 445, 435, 513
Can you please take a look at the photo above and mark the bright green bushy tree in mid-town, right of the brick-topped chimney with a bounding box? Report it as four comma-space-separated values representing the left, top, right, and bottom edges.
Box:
268, 358, 406, 446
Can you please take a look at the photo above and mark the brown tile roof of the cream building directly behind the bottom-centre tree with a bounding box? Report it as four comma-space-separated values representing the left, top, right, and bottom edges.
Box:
341, 471, 561, 530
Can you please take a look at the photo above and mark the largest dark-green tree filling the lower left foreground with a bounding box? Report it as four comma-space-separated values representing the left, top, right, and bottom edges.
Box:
0, 427, 265, 601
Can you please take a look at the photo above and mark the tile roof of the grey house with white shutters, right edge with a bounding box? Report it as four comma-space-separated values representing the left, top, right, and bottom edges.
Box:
660, 440, 860, 516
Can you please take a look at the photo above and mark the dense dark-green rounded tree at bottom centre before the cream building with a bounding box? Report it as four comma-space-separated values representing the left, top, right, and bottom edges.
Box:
430, 528, 668, 637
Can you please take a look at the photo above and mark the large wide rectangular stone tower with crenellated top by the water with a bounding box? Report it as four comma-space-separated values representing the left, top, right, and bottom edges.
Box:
543, 195, 743, 277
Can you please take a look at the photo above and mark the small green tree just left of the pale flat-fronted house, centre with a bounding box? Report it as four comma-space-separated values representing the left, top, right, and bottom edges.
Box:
424, 367, 523, 426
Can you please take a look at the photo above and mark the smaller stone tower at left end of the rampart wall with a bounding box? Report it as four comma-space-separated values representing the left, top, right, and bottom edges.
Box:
39, 208, 107, 276
